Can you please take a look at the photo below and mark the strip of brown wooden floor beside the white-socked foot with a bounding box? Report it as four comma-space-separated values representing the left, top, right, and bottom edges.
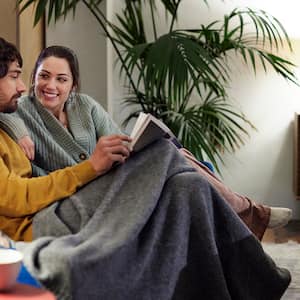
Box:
263, 220, 300, 244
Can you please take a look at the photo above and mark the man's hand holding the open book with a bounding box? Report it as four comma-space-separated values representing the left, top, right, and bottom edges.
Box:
89, 135, 131, 175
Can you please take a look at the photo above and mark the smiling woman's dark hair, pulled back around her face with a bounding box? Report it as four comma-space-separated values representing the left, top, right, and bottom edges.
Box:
30, 46, 80, 94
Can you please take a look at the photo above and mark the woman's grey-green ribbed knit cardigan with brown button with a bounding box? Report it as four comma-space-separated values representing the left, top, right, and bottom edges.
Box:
0, 94, 121, 175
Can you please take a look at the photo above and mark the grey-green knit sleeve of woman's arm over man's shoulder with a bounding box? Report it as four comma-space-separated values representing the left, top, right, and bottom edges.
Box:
0, 113, 29, 142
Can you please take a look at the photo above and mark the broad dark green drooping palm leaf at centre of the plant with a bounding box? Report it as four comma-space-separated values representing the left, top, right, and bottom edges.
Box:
120, 31, 227, 101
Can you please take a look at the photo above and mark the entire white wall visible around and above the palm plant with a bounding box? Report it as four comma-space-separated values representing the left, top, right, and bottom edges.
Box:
108, 0, 300, 219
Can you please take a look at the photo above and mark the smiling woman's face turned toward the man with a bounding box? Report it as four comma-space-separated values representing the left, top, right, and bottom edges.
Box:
34, 56, 73, 115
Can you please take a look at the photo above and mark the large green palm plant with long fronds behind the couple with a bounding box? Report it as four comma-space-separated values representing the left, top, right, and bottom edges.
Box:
18, 0, 297, 170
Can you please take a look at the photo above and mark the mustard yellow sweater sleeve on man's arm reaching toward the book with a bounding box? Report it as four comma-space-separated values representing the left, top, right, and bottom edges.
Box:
0, 158, 96, 217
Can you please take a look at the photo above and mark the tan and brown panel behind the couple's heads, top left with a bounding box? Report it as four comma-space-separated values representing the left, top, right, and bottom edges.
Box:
0, 0, 44, 86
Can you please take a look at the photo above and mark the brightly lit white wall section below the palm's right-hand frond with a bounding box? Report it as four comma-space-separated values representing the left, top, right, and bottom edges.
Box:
222, 47, 300, 218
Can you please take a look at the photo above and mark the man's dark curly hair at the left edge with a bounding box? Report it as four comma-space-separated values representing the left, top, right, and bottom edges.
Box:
0, 37, 23, 78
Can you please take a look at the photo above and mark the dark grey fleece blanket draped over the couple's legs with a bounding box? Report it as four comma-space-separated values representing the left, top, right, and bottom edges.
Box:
17, 140, 290, 300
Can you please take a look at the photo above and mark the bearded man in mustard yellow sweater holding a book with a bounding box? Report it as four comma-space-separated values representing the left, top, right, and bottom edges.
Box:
0, 38, 130, 241
